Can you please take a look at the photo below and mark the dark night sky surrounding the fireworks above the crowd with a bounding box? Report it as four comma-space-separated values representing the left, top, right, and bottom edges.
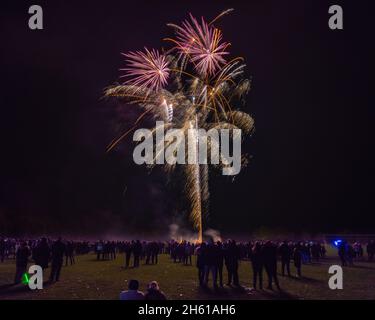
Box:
0, 0, 375, 233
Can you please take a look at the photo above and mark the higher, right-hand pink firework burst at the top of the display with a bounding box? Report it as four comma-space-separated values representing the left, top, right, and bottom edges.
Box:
176, 14, 230, 76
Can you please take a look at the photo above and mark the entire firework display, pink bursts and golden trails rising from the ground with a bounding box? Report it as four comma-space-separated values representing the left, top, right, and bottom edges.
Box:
105, 9, 254, 241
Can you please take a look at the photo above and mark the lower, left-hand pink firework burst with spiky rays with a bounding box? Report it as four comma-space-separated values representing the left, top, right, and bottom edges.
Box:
120, 48, 170, 91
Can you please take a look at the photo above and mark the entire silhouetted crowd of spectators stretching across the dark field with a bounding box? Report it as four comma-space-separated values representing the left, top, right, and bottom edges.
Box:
0, 237, 375, 300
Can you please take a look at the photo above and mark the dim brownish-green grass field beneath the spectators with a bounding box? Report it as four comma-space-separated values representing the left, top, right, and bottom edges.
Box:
0, 246, 375, 300
